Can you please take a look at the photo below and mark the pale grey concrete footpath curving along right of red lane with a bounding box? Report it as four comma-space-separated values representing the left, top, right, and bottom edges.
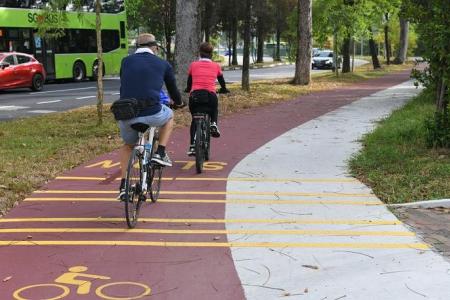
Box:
226, 82, 450, 299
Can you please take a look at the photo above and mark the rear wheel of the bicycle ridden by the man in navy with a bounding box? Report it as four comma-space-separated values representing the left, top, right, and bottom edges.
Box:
125, 149, 142, 228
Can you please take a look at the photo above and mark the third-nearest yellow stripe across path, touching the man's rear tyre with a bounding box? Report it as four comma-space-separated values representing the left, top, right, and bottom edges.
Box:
0, 217, 402, 225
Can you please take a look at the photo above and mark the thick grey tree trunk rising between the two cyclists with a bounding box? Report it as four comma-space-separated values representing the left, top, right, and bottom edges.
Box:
175, 0, 201, 98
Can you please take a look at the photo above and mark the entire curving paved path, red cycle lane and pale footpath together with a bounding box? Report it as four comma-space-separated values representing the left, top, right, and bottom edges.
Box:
0, 72, 450, 300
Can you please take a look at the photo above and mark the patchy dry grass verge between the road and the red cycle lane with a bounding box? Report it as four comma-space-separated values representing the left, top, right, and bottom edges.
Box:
0, 65, 411, 215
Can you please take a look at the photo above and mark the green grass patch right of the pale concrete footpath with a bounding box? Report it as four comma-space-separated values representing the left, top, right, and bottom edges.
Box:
350, 92, 450, 203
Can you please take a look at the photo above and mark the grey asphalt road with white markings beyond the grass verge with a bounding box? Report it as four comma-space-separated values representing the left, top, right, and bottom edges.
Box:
0, 60, 366, 121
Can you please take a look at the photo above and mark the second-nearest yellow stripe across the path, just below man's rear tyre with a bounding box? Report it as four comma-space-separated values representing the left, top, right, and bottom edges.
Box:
0, 228, 415, 236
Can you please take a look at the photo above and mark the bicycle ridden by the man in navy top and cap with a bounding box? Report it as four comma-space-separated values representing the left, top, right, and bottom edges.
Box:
124, 123, 164, 228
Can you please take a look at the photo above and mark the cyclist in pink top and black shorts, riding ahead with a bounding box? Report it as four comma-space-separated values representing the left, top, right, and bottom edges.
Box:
185, 42, 230, 156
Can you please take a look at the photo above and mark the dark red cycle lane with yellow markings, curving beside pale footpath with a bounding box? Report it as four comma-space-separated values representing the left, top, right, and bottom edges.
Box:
0, 72, 408, 300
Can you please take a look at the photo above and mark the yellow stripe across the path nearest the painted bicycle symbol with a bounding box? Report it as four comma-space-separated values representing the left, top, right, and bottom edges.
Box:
0, 241, 429, 250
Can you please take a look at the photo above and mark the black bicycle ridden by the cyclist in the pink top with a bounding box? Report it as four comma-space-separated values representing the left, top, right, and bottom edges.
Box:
192, 113, 211, 174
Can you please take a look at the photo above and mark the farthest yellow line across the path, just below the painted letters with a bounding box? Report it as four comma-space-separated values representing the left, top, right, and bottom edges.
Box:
56, 176, 359, 183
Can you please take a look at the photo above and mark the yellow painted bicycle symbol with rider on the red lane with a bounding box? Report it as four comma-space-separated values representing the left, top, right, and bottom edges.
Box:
13, 266, 151, 300
